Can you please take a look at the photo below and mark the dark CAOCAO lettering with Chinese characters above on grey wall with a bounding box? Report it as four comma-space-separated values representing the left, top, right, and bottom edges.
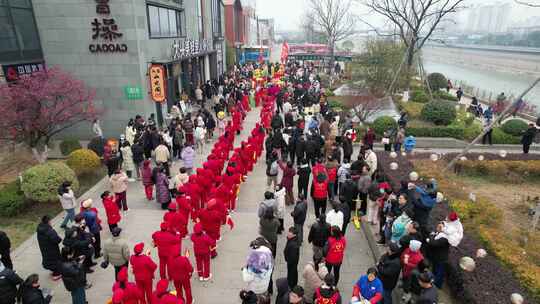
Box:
88, 0, 128, 53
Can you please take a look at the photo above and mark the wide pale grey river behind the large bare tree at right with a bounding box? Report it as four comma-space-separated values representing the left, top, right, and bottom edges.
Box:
423, 48, 540, 109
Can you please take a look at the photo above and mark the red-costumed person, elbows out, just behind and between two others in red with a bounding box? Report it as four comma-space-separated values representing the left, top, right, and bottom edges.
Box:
152, 222, 182, 279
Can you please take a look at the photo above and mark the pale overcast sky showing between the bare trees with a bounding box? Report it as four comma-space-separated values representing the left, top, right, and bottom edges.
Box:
254, 0, 540, 31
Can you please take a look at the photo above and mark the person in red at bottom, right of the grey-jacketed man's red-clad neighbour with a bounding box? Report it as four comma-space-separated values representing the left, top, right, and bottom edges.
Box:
169, 255, 193, 304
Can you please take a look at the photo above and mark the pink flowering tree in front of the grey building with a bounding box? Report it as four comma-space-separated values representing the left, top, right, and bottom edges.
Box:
0, 68, 99, 162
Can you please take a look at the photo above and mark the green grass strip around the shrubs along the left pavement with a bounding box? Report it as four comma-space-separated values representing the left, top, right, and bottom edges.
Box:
0, 168, 106, 248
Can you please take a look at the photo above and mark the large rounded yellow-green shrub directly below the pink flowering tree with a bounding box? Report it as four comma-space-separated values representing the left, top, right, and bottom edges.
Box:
21, 161, 79, 202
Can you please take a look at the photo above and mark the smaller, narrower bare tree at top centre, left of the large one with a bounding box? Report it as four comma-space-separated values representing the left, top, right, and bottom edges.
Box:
308, 0, 356, 73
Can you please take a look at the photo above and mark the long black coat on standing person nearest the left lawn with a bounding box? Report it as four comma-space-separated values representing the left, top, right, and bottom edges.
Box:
37, 223, 62, 270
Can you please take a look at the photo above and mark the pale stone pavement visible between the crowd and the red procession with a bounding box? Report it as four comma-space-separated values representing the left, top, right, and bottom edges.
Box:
12, 105, 374, 304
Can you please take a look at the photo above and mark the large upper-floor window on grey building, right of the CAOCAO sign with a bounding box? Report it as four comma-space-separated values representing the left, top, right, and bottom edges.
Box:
147, 4, 185, 38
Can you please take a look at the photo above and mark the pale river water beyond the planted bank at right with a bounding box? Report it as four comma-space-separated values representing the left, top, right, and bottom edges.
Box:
424, 59, 540, 109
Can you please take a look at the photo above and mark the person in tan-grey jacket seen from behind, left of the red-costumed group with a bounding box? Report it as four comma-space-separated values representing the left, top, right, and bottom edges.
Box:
102, 227, 130, 279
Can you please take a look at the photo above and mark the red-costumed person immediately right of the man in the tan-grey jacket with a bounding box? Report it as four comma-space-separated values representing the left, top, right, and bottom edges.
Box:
129, 243, 157, 304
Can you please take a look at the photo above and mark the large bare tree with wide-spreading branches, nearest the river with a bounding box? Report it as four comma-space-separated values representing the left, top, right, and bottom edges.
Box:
362, 0, 465, 69
